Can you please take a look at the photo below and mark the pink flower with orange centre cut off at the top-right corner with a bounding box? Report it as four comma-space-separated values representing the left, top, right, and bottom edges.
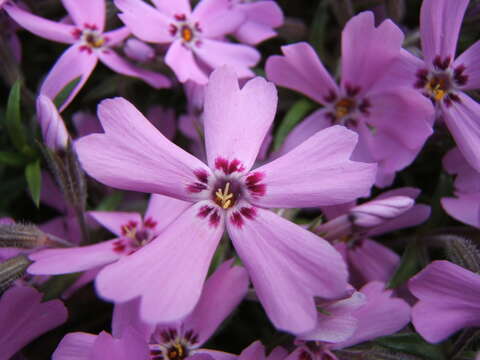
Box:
391, 0, 480, 171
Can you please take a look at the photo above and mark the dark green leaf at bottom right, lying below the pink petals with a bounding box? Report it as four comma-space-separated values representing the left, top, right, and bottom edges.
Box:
375, 333, 445, 360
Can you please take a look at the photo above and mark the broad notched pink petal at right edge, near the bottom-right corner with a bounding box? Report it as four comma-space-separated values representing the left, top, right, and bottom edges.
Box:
408, 260, 480, 343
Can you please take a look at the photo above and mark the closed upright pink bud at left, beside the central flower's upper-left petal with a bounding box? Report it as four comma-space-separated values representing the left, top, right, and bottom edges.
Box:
37, 95, 69, 151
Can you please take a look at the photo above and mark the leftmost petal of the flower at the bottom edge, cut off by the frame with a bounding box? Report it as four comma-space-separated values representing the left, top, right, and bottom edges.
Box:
52, 332, 97, 360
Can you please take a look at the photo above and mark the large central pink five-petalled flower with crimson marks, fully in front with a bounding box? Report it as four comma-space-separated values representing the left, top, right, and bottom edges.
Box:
76, 68, 376, 331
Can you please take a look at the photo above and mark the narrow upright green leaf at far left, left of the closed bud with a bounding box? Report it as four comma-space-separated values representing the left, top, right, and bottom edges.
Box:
5, 80, 29, 153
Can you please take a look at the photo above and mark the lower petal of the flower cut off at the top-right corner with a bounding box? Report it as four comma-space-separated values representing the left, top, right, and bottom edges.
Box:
442, 93, 480, 171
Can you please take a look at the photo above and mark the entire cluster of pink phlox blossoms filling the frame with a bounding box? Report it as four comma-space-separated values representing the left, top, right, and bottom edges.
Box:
0, 0, 480, 360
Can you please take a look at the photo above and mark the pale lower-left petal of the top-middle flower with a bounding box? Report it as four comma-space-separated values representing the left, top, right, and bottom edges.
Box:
165, 40, 208, 84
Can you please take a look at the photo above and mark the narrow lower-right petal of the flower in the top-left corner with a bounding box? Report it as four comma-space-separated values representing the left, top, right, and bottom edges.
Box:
98, 50, 171, 89
